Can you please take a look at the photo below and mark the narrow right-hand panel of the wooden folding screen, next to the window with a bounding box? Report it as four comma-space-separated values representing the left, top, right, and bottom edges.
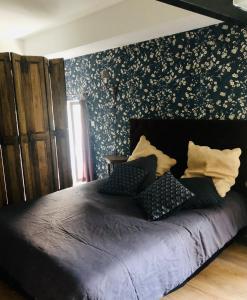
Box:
49, 59, 72, 189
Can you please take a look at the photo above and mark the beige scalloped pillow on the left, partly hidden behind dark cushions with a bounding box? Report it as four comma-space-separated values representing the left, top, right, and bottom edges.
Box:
128, 135, 177, 176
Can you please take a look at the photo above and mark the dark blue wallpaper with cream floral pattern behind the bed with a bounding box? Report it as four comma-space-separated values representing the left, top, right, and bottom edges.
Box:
65, 23, 247, 177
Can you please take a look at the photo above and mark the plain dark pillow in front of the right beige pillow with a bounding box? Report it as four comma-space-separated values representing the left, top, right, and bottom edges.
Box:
179, 177, 223, 209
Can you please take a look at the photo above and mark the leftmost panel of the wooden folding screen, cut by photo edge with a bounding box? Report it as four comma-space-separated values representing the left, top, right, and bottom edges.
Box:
0, 53, 25, 203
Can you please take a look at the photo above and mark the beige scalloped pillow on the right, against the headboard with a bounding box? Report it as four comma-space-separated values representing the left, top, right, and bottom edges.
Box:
182, 142, 241, 197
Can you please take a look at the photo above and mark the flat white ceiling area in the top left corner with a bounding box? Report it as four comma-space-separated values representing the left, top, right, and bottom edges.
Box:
0, 0, 123, 39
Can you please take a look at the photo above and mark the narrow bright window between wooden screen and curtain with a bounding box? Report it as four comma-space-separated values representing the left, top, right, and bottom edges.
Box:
67, 101, 83, 185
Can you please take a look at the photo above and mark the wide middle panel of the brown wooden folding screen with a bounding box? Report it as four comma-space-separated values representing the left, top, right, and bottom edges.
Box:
12, 54, 54, 200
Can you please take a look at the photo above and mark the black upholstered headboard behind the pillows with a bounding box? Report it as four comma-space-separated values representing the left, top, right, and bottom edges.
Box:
130, 119, 247, 194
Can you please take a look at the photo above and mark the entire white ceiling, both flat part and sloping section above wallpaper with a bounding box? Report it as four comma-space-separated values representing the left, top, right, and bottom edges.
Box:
0, 0, 220, 58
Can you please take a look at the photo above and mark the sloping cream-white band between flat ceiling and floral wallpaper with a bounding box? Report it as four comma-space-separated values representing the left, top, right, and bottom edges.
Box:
23, 0, 219, 58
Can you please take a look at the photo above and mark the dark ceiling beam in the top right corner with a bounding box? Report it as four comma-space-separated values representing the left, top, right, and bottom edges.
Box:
158, 0, 247, 25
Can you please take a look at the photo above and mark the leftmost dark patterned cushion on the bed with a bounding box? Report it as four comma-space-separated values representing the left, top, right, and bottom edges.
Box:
99, 163, 147, 196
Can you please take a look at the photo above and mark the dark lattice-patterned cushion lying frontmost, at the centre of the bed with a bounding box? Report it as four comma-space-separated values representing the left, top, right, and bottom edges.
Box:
135, 172, 194, 220
